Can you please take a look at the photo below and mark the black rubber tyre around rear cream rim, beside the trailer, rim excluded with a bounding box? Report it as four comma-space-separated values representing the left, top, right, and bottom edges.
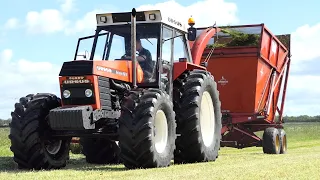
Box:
174, 70, 222, 163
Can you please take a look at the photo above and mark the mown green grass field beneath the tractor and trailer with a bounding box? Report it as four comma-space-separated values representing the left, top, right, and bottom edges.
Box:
0, 123, 320, 180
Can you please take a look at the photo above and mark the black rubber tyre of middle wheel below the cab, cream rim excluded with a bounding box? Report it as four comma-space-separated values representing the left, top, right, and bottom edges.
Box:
119, 89, 176, 169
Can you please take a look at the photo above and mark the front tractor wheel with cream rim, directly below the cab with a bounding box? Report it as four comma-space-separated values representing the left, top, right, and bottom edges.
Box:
119, 89, 176, 169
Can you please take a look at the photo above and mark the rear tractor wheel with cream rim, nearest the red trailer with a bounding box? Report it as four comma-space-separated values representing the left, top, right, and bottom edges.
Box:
174, 70, 222, 163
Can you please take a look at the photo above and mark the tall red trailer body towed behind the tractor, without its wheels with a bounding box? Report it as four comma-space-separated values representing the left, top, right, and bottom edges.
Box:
198, 24, 290, 148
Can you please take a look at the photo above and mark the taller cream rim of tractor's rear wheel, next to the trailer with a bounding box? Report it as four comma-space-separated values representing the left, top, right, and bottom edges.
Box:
200, 91, 215, 147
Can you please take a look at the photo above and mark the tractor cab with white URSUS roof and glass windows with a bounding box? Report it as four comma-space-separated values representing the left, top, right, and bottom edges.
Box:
74, 10, 192, 94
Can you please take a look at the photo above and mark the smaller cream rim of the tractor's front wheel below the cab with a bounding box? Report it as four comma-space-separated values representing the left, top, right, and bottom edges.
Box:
154, 110, 168, 153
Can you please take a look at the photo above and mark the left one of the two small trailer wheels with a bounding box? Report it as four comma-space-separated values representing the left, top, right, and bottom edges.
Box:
262, 127, 281, 154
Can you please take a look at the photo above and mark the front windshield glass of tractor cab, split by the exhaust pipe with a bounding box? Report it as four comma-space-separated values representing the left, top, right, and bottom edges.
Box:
75, 23, 161, 83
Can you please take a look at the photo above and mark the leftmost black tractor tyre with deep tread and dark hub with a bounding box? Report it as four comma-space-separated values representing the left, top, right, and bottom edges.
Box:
9, 94, 71, 170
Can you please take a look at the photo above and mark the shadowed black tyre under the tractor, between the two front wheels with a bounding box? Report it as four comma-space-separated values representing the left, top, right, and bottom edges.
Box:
80, 137, 120, 164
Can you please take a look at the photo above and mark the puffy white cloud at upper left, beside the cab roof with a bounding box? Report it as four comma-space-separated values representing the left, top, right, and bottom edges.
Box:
26, 9, 68, 33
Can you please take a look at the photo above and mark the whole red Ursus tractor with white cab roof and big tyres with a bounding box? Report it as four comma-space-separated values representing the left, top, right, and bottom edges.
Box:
9, 9, 222, 169
